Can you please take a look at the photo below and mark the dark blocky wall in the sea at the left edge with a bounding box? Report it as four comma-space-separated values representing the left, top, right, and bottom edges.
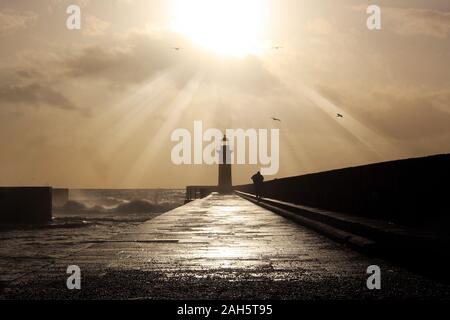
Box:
0, 187, 52, 224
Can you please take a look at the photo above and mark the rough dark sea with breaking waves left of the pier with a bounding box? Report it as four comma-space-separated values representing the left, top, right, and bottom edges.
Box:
0, 189, 185, 287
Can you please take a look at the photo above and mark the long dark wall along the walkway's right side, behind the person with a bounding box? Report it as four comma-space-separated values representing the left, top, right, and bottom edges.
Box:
235, 154, 450, 225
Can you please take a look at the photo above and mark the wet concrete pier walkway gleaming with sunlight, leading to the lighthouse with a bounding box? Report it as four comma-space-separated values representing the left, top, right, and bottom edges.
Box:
0, 194, 450, 299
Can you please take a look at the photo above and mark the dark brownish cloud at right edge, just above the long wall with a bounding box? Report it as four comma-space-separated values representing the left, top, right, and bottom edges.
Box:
318, 85, 450, 141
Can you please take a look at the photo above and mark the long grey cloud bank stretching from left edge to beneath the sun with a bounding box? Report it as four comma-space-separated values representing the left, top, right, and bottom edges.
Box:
0, 33, 279, 115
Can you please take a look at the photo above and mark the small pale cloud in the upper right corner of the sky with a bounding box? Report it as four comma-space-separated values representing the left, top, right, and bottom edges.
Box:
386, 8, 450, 38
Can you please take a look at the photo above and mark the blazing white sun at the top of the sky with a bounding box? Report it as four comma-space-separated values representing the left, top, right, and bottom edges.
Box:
172, 0, 267, 57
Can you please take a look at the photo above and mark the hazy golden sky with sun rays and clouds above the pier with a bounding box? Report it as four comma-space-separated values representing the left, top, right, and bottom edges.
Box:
0, 0, 450, 188
